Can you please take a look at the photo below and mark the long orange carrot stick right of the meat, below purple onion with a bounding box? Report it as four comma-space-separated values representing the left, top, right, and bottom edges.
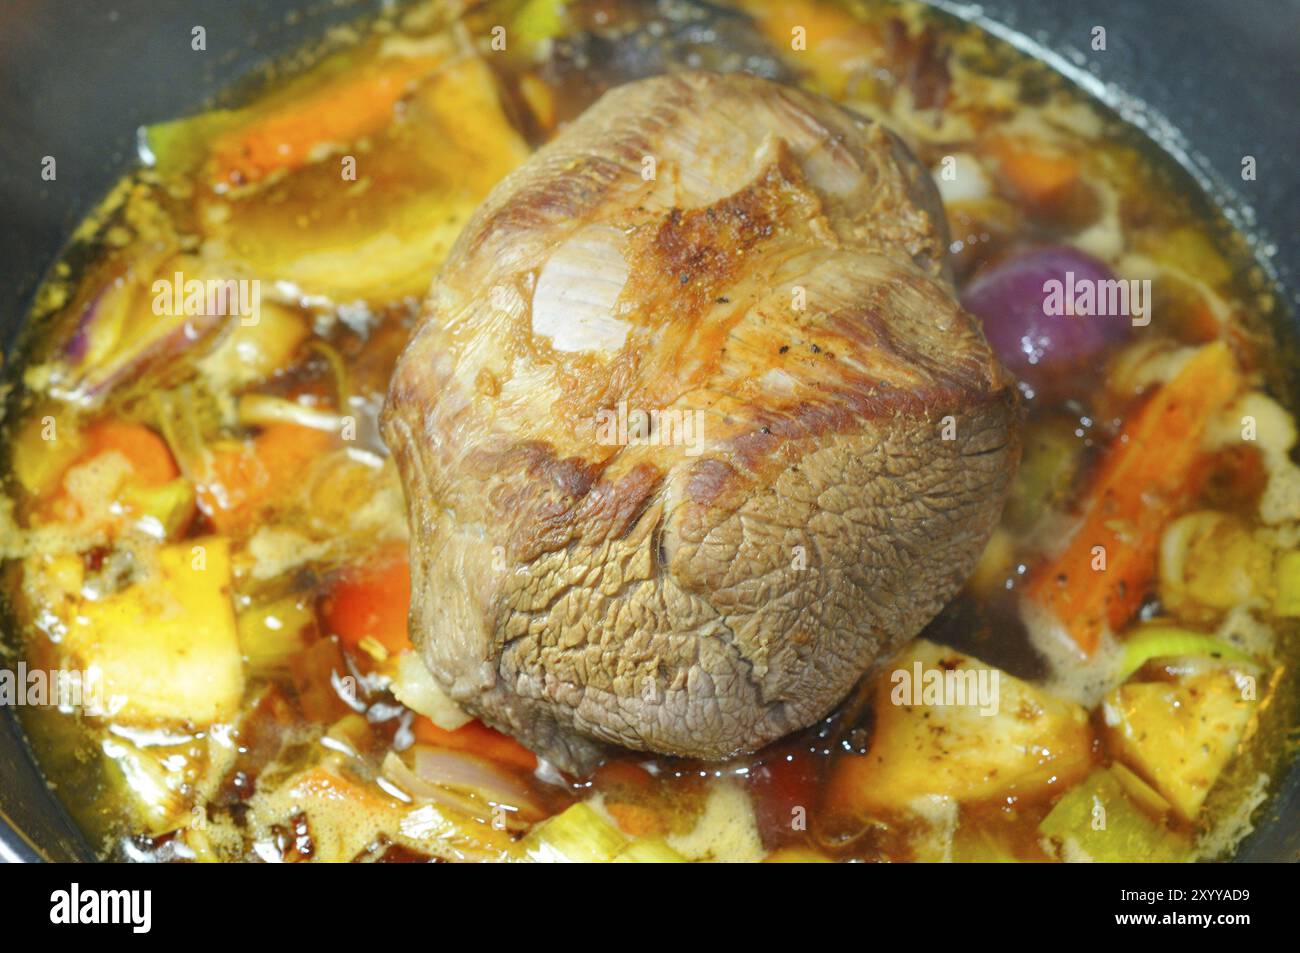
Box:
1027, 342, 1240, 654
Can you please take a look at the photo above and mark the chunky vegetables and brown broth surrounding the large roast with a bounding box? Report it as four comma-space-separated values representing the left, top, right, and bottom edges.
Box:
0, 0, 1300, 861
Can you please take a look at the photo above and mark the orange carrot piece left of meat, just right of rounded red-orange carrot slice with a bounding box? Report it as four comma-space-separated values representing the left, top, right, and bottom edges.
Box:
195, 424, 333, 533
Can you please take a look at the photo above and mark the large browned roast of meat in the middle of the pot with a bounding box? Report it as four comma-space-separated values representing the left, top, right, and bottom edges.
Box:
384, 73, 1019, 771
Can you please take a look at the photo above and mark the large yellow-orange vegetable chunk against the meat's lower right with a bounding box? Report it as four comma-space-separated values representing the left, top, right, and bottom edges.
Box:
827, 640, 1092, 816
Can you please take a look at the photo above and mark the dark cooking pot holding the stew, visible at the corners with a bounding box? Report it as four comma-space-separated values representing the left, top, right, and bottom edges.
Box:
0, 0, 1300, 861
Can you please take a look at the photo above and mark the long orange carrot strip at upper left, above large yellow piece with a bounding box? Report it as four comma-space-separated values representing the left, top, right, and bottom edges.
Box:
211, 57, 438, 185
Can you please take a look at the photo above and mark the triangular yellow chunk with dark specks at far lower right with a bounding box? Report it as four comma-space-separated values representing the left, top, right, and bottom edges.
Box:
1102, 671, 1256, 820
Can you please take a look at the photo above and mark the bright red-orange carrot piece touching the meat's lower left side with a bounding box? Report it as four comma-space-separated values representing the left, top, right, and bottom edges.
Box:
324, 546, 412, 655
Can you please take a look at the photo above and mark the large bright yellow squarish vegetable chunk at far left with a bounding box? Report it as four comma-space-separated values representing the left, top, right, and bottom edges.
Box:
64, 537, 243, 725
